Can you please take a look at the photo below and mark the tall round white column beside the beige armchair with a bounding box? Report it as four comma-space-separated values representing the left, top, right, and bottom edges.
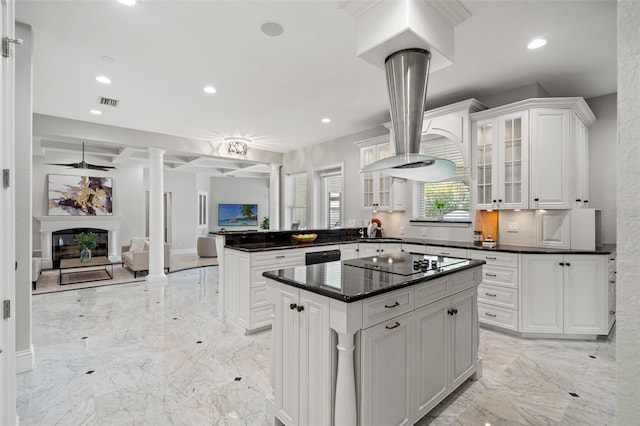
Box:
147, 148, 169, 281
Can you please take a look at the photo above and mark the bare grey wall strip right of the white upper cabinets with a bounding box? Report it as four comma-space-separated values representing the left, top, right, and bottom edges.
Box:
587, 93, 618, 243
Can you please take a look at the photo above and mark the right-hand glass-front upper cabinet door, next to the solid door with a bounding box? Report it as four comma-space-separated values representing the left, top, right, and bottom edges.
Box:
497, 111, 529, 209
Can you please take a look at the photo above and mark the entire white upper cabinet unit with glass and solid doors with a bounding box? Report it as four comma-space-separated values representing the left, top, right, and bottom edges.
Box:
471, 98, 595, 209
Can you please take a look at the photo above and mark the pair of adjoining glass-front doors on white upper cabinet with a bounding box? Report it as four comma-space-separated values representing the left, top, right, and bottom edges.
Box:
472, 111, 529, 209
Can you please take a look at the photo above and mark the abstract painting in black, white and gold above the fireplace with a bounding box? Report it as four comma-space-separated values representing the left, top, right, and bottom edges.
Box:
49, 174, 113, 216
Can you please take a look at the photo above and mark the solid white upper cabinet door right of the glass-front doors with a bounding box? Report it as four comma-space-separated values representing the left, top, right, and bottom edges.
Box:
531, 108, 574, 209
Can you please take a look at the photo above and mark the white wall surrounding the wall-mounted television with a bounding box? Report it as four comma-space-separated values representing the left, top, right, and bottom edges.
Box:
209, 177, 269, 231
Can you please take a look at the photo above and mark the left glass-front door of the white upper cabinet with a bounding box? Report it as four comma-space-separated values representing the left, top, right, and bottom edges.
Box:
475, 120, 497, 209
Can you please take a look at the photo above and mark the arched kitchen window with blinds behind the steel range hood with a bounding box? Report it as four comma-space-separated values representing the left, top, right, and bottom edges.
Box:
413, 138, 470, 221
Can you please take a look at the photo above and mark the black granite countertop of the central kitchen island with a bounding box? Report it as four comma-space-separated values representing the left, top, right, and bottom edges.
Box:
262, 253, 485, 303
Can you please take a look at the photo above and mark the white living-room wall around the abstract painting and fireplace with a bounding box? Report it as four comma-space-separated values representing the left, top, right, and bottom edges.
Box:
32, 151, 145, 250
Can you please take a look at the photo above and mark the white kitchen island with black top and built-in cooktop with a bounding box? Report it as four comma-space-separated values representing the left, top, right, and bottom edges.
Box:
263, 252, 484, 425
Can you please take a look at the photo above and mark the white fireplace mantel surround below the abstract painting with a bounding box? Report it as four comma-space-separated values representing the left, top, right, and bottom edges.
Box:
35, 216, 122, 269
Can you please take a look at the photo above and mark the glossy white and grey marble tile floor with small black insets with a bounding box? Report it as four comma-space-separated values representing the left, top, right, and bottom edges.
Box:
17, 266, 615, 426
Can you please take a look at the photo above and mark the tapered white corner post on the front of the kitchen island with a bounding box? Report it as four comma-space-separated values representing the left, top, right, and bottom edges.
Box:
334, 332, 358, 426
